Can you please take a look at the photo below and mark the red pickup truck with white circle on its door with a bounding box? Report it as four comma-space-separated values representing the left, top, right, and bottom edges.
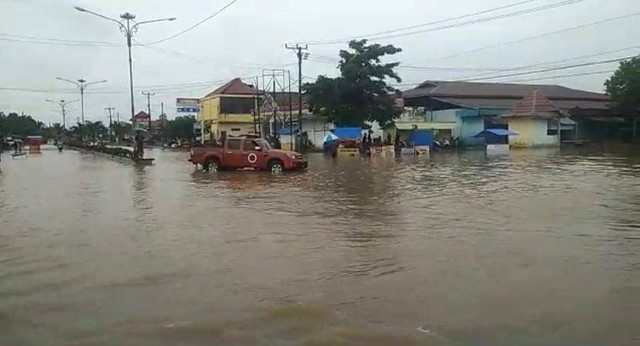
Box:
189, 136, 308, 173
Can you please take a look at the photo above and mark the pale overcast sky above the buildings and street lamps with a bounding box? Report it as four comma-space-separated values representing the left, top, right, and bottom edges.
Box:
0, 0, 640, 123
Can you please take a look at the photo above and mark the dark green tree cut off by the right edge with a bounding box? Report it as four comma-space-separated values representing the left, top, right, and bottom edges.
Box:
604, 57, 640, 114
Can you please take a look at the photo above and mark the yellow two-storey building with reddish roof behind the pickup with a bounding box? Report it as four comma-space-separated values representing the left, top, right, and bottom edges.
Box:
198, 78, 257, 139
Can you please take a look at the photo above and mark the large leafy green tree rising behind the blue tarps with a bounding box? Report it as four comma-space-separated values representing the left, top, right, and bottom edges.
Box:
303, 40, 402, 126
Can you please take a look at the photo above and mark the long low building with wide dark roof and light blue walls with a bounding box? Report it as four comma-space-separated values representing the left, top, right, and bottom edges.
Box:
398, 81, 612, 144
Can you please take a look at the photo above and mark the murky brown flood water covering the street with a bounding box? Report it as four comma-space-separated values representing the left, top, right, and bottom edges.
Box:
0, 149, 640, 346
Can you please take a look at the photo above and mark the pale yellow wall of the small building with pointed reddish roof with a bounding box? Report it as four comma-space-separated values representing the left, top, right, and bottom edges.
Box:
509, 118, 558, 148
